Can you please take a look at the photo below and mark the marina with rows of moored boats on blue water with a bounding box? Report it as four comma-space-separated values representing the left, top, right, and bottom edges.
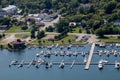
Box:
0, 44, 120, 80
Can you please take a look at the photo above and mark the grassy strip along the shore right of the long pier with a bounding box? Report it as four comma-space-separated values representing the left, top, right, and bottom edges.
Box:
99, 36, 120, 43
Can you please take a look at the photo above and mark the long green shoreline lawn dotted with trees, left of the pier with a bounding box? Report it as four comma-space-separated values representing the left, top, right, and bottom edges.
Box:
28, 35, 86, 45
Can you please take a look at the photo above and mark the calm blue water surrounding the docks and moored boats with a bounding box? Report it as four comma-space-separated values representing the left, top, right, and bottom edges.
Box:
0, 45, 120, 80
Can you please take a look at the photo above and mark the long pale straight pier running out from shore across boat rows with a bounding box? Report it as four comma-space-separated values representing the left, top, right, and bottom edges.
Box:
85, 43, 95, 70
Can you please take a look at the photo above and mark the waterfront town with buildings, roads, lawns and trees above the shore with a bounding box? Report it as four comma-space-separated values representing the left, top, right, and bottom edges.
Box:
0, 5, 120, 48
